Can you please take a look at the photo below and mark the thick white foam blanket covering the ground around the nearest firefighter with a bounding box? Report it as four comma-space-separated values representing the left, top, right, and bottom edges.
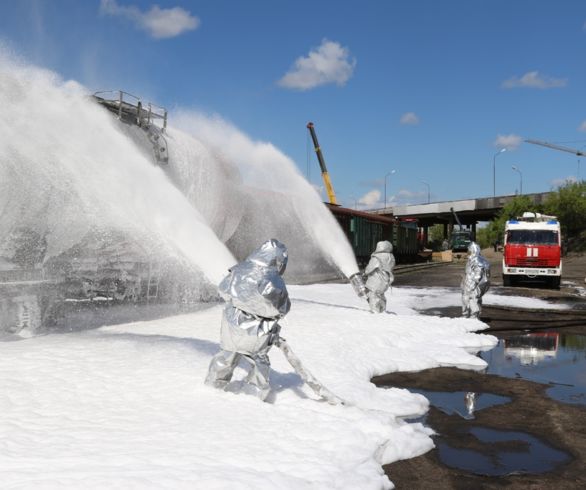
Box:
0, 284, 496, 489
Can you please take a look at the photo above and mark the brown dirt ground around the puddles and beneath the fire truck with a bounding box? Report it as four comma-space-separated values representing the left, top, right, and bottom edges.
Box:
373, 250, 586, 490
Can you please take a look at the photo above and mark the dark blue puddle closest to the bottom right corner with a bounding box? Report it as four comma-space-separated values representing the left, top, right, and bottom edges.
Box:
436, 427, 570, 476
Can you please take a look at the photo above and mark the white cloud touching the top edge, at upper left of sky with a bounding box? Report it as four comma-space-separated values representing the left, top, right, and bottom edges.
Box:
100, 0, 200, 39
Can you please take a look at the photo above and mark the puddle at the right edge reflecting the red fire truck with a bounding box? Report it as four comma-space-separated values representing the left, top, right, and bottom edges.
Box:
479, 331, 586, 405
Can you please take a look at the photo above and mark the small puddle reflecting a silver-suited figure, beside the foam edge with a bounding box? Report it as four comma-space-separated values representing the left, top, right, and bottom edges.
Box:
408, 388, 511, 420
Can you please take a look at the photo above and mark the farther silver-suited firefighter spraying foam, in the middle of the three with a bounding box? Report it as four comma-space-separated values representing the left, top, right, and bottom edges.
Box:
364, 240, 395, 313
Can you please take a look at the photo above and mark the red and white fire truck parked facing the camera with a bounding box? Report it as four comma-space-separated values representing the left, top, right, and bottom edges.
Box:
503, 212, 562, 288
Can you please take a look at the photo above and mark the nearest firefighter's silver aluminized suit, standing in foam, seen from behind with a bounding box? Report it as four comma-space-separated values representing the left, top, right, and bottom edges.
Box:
206, 239, 291, 400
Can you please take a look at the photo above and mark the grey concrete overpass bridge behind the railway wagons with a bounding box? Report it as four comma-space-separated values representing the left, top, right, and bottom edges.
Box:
370, 192, 551, 236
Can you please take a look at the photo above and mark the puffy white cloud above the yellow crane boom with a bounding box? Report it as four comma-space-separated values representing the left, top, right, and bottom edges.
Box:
278, 39, 356, 90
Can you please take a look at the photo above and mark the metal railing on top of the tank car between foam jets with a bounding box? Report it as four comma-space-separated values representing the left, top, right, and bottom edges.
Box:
93, 90, 167, 132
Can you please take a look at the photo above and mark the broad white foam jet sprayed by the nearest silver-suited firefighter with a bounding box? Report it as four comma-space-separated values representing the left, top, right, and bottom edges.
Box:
0, 52, 236, 284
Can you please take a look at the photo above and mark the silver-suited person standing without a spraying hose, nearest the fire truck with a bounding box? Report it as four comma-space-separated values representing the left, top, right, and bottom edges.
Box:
461, 242, 490, 318
